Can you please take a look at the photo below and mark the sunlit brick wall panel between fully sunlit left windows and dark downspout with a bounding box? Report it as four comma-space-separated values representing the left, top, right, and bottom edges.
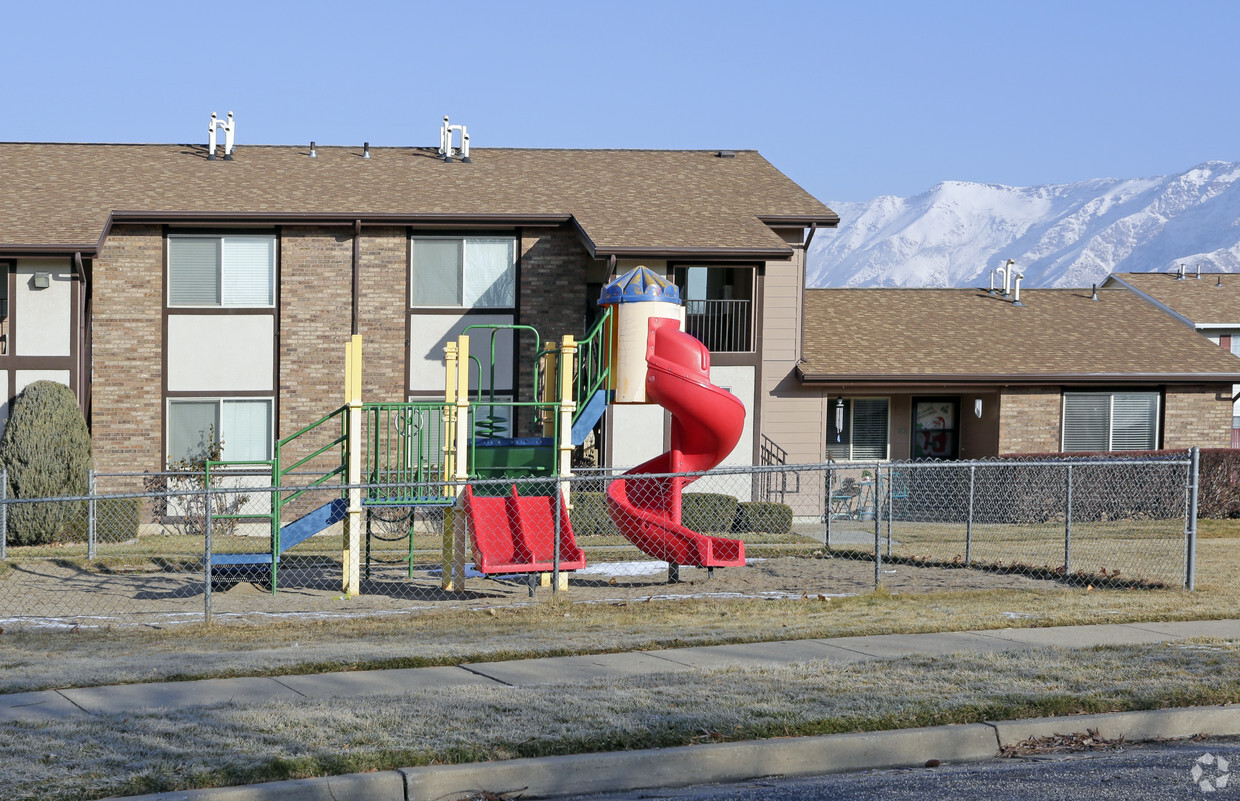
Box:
279, 228, 354, 456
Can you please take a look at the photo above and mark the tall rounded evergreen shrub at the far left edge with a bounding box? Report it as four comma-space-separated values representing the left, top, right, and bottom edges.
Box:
0, 381, 92, 546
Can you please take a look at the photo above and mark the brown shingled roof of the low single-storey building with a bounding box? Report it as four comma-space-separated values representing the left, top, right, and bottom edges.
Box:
797, 289, 1240, 384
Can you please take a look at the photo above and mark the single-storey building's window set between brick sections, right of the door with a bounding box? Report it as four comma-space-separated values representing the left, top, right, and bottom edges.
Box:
1064, 392, 1158, 451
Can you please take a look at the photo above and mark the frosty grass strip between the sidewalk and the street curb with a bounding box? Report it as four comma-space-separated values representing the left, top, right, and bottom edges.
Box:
0, 640, 1240, 801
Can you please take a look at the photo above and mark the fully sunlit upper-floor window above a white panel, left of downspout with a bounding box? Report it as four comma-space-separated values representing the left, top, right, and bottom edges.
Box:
167, 236, 275, 308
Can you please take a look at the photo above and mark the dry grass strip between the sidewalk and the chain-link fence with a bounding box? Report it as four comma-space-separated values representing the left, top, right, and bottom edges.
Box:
7, 577, 1240, 692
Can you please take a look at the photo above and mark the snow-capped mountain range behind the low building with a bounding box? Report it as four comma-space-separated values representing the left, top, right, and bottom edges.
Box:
807, 161, 1240, 286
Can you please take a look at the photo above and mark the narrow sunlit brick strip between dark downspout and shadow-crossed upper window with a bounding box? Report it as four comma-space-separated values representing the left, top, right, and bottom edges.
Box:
357, 228, 409, 403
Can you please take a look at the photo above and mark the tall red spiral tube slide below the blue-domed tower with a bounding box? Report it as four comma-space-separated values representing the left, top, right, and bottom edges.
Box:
608, 317, 745, 568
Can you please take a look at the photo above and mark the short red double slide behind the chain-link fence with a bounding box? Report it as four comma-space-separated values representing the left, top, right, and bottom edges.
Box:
465, 485, 585, 575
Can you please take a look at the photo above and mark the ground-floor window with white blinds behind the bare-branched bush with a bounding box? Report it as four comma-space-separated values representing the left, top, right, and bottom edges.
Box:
167, 398, 272, 461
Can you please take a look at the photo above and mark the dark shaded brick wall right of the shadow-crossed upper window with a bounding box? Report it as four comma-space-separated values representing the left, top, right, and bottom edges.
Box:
517, 226, 591, 435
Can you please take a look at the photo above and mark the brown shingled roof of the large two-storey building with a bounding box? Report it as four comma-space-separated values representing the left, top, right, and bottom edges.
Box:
0, 143, 839, 258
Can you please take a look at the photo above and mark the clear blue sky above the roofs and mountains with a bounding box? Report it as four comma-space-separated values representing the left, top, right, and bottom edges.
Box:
0, 0, 1240, 201
